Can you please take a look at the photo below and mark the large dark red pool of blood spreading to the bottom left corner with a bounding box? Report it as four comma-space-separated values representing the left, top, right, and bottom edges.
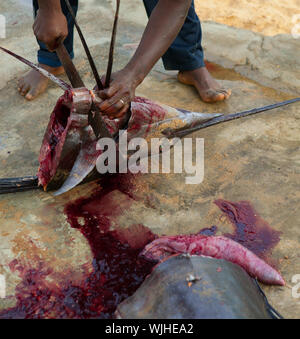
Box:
0, 175, 155, 318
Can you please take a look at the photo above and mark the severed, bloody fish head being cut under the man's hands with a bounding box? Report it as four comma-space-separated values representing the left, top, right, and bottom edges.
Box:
38, 88, 221, 195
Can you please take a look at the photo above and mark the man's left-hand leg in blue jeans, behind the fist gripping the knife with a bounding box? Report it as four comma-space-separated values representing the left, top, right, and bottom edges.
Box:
18, 0, 78, 100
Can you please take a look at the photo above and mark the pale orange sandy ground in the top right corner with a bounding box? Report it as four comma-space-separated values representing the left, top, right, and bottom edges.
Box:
195, 0, 300, 35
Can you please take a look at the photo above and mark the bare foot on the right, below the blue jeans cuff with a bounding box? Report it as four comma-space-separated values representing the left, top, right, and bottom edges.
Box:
178, 67, 231, 103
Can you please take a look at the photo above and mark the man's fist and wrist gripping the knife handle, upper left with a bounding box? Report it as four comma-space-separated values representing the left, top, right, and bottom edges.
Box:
33, 0, 68, 51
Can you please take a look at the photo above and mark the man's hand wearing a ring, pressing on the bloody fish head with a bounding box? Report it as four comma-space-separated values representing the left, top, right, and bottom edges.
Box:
99, 68, 139, 119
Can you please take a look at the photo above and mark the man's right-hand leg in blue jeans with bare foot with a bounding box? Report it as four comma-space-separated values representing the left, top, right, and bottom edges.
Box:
143, 0, 231, 102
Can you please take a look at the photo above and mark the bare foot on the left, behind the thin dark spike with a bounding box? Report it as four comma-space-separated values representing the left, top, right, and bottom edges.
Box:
18, 64, 64, 100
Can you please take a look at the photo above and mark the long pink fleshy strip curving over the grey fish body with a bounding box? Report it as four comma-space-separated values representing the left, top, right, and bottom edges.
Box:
141, 235, 285, 286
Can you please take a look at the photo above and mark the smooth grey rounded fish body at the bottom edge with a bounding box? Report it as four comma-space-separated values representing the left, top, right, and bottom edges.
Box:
115, 255, 281, 320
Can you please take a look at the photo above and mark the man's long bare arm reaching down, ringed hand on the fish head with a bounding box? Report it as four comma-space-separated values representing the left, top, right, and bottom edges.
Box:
100, 0, 191, 117
